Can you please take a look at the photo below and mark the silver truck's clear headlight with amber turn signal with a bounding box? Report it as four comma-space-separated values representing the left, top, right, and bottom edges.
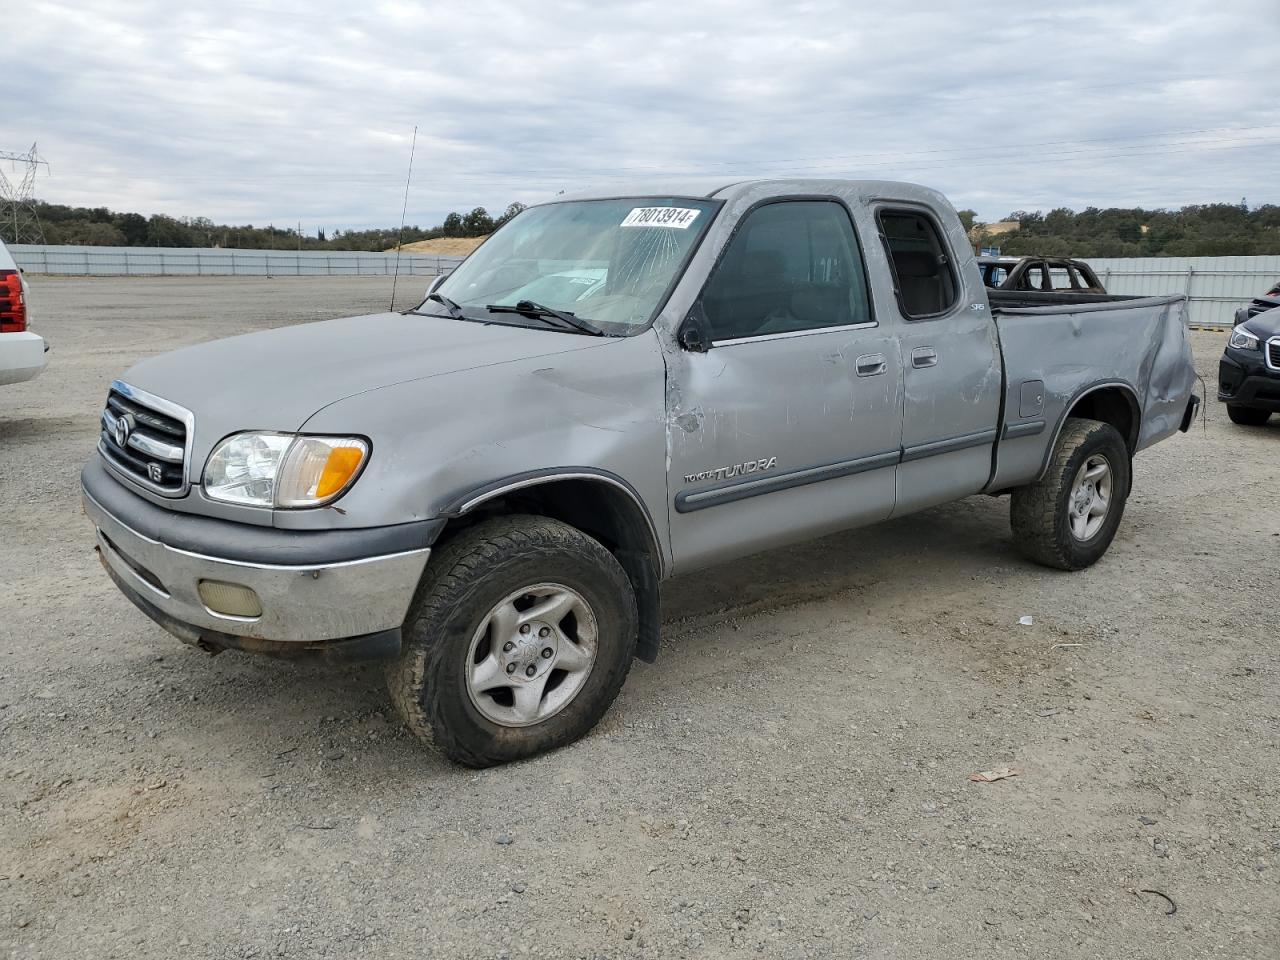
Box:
205, 434, 369, 507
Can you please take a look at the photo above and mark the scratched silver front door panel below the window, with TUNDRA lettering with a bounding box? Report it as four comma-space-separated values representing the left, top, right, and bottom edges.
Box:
667, 328, 902, 572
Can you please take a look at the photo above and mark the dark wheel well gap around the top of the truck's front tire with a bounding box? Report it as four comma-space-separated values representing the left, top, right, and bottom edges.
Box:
436, 477, 662, 663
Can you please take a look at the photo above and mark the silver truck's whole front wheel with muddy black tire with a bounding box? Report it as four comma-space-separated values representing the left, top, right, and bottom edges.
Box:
388, 516, 639, 767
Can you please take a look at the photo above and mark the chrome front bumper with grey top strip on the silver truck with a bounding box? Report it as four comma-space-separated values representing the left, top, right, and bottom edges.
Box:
81, 458, 443, 657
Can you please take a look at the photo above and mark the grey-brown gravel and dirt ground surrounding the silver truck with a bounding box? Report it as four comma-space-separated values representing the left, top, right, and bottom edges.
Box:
0, 278, 1280, 960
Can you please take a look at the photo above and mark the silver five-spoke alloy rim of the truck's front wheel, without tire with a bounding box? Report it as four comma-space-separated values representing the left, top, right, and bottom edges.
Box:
466, 582, 599, 727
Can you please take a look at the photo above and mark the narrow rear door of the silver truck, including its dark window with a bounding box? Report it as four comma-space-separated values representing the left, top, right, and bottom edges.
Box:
876, 204, 1002, 516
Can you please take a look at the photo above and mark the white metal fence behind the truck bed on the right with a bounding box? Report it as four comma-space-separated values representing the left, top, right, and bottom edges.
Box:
1088, 256, 1280, 328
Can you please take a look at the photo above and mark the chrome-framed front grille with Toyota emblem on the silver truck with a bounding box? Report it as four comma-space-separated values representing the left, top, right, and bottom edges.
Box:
97, 380, 195, 497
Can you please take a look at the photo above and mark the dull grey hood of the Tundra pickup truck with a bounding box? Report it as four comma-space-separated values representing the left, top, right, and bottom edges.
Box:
123, 314, 609, 448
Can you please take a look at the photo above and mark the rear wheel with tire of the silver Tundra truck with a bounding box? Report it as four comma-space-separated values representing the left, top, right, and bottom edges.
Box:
1009, 417, 1132, 570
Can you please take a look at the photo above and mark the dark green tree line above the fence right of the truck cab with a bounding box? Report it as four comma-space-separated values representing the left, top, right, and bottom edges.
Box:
972, 200, 1280, 257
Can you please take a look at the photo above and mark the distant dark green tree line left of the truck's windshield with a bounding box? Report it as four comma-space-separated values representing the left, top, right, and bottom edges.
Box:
16, 201, 525, 250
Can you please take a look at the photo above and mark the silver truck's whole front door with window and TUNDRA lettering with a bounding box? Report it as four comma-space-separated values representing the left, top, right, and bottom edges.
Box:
667, 197, 902, 572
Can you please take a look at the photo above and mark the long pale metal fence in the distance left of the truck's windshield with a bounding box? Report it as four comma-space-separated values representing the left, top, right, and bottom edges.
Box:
9, 243, 462, 276
